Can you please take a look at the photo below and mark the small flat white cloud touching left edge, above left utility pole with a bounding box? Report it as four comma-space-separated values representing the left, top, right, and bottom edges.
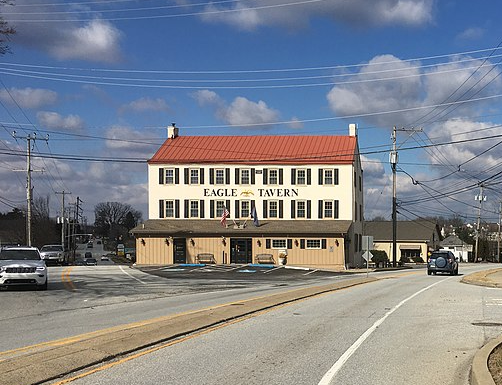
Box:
0, 87, 58, 109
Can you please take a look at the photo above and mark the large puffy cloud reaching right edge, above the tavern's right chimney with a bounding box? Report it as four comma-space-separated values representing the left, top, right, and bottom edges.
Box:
327, 55, 502, 128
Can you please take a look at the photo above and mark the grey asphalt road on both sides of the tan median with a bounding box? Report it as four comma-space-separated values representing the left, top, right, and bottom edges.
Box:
0, 265, 502, 384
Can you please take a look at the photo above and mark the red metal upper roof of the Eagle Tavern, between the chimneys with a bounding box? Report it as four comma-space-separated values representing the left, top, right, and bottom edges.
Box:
148, 135, 357, 164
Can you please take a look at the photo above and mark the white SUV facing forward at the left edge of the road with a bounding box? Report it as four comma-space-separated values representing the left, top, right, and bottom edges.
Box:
0, 246, 47, 290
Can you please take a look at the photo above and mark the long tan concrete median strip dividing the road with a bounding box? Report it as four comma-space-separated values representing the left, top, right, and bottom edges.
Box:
0, 277, 378, 385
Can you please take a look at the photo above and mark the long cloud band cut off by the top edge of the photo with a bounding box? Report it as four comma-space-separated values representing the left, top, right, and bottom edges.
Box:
203, 0, 434, 30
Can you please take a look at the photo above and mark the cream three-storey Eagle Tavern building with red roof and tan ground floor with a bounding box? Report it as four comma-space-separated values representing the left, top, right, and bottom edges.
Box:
132, 125, 363, 270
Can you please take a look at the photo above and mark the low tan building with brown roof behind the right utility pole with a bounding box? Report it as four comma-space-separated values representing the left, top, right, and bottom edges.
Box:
363, 220, 441, 262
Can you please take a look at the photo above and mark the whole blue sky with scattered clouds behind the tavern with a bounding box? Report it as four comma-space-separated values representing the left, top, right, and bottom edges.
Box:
0, 0, 502, 222
